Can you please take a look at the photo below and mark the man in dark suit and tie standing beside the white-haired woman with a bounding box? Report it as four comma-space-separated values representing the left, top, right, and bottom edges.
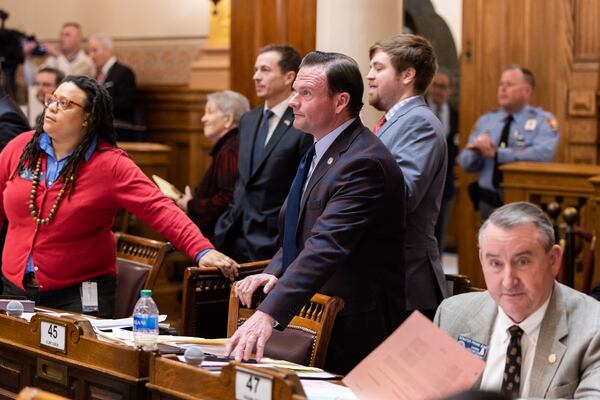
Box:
215, 45, 312, 262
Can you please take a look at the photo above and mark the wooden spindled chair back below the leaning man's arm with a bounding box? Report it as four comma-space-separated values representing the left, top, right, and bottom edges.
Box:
227, 284, 344, 368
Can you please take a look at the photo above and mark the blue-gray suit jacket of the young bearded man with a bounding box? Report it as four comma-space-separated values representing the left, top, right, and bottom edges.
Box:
377, 96, 448, 310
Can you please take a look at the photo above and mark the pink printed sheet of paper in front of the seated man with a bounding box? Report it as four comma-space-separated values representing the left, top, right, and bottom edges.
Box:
343, 312, 485, 400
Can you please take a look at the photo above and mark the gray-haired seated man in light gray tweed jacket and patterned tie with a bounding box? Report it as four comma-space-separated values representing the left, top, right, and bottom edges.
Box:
434, 202, 600, 399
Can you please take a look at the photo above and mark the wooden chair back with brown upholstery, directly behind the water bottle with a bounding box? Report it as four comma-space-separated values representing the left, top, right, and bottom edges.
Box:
114, 233, 173, 318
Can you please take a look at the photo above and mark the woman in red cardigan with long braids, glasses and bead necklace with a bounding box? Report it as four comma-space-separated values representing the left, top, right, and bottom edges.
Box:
0, 76, 238, 316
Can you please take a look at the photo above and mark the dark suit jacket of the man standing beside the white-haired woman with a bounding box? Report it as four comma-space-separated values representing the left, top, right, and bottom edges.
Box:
215, 106, 313, 262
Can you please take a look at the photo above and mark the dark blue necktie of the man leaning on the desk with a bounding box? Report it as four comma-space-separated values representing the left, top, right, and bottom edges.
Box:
282, 144, 315, 271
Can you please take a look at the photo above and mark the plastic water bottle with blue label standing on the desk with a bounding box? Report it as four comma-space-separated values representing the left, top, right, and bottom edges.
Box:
133, 290, 158, 350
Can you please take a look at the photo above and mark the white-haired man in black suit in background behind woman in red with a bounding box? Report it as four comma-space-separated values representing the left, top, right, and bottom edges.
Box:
88, 33, 141, 141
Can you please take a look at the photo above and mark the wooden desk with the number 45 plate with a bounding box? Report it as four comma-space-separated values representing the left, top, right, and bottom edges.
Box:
0, 314, 150, 400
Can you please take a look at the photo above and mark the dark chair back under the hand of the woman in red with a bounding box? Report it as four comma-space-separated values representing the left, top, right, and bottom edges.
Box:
181, 260, 271, 339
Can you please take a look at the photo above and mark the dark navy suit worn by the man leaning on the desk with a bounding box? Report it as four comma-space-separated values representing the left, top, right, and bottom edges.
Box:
259, 119, 405, 374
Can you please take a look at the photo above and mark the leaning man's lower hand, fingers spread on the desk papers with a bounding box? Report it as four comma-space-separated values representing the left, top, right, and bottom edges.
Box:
225, 310, 275, 362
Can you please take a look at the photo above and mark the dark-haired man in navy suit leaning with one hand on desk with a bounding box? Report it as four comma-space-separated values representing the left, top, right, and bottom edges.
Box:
227, 52, 405, 374
